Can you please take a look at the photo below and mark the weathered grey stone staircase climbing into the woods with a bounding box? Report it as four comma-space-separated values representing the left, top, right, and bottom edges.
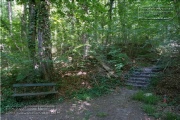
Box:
126, 66, 162, 88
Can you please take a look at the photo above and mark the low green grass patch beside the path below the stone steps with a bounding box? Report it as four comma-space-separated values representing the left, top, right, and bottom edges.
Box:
132, 91, 180, 120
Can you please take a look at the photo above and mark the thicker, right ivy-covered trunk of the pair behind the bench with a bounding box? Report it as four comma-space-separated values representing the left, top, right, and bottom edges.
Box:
38, 0, 53, 81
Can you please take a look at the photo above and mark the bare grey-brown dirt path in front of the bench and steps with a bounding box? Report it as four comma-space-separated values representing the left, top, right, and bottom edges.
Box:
2, 88, 154, 120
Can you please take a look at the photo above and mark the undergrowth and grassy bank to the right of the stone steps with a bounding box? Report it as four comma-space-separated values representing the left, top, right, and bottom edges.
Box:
132, 53, 180, 120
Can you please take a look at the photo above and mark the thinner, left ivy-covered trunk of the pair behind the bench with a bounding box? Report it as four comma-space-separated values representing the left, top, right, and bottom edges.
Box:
28, 0, 37, 66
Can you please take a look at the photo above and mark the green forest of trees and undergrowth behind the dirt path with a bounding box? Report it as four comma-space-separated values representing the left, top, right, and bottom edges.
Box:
0, 0, 180, 120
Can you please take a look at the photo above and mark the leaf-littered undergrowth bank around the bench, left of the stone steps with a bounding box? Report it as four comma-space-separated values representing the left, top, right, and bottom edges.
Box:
1, 45, 126, 113
